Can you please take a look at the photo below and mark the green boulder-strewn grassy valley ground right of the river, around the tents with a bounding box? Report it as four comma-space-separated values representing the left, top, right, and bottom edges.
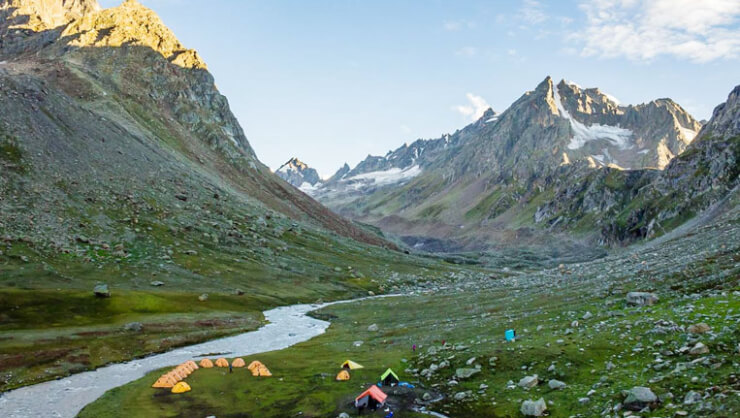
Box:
80, 198, 740, 417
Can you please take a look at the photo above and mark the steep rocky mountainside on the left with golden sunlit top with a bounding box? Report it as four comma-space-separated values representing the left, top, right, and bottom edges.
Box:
0, 1, 394, 248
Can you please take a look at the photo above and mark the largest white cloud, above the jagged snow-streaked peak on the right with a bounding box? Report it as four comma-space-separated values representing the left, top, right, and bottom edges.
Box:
570, 0, 740, 62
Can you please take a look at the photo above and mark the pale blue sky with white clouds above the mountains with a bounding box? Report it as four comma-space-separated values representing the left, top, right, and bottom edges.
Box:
99, 0, 740, 177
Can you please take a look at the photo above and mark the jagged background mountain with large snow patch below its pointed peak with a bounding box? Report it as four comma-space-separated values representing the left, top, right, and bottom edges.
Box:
314, 77, 724, 249
